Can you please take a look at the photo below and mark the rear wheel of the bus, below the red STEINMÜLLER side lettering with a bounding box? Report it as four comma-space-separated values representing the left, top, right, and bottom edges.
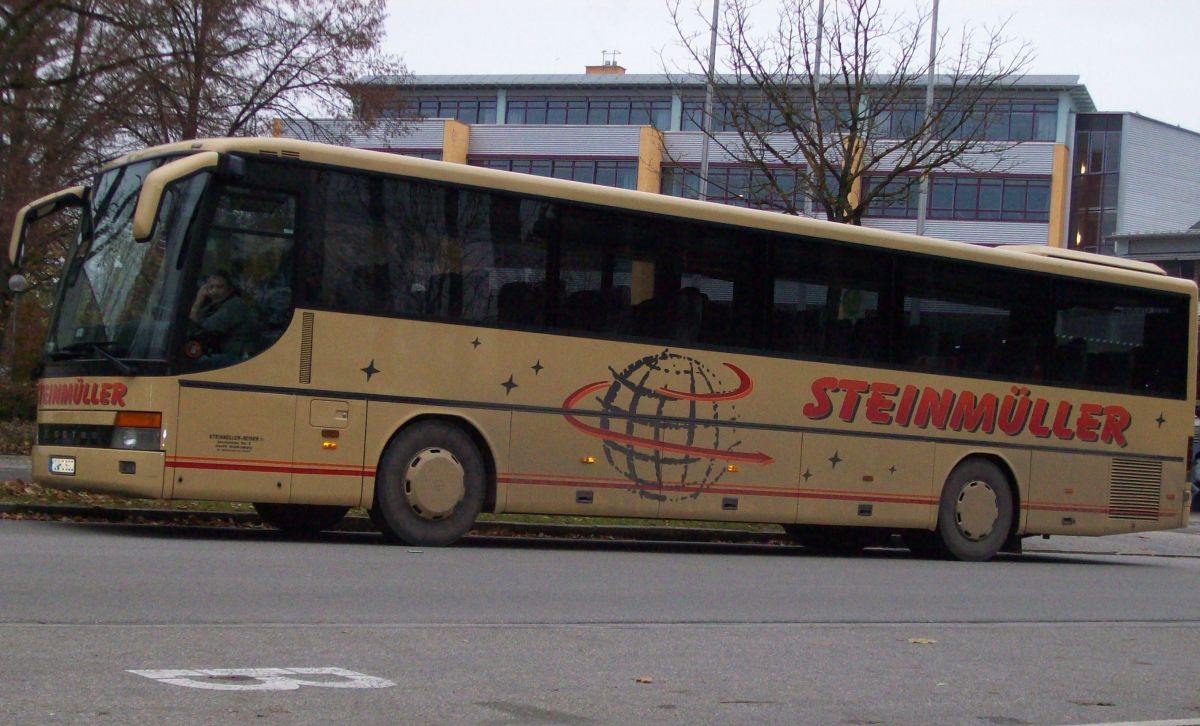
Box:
937, 458, 1013, 562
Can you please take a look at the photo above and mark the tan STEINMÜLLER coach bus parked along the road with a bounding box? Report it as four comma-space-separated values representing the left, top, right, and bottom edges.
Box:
10, 138, 1196, 560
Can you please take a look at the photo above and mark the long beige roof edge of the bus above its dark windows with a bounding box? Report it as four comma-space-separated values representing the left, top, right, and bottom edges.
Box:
106, 137, 1196, 295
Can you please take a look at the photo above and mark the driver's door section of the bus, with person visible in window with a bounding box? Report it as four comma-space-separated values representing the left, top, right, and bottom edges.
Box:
173, 167, 309, 503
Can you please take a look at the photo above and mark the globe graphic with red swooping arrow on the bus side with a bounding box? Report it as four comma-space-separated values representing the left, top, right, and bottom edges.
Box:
565, 350, 772, 502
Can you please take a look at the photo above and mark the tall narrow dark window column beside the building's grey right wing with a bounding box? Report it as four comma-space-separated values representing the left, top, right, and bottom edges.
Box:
1067, 114, 1121, 254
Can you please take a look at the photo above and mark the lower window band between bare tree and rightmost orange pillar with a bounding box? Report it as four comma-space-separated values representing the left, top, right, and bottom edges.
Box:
929, 176, 1050, 222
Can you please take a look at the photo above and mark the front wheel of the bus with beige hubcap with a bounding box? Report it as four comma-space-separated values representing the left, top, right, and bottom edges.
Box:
373, 421, 487, 547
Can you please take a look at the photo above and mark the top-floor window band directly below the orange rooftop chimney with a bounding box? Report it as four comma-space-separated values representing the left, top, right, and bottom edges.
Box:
504, 96, 671, 130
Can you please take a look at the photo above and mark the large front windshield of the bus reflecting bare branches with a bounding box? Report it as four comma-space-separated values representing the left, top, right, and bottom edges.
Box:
46, 157, 208, 364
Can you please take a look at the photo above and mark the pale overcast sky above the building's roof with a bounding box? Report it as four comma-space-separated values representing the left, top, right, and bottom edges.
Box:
386, 0, 1200, 132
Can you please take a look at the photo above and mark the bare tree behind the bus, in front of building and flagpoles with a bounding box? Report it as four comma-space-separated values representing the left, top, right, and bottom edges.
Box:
667, 0, 1031, 224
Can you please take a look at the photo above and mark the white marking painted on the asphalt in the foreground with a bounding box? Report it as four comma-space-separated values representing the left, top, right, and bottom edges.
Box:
128, 668, 396, 691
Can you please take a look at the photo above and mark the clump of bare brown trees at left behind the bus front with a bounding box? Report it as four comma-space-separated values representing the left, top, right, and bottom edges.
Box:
0, 0, 403, 379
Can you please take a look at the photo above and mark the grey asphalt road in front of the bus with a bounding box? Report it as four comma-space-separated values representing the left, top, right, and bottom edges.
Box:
0, 521, 1200, 724
